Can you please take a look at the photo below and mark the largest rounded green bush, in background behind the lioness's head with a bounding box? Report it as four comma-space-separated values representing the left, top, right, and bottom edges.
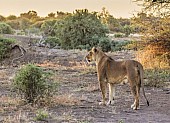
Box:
54, 9, 109, 49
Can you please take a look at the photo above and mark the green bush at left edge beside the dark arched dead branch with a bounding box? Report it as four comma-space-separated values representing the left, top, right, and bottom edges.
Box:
0, 37, 15, 61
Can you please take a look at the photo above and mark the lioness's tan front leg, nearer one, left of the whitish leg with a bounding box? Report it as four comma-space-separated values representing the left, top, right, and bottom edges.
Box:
99, 81, 106, 105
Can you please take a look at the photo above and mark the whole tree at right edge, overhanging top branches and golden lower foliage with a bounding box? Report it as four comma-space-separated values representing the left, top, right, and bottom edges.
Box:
133, 0, 170, 67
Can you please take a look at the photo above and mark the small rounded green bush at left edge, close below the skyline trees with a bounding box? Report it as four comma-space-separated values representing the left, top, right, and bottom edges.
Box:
0, 22, 14, 34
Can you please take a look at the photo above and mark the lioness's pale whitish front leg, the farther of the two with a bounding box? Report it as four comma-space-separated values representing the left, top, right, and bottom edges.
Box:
107, 83, 115, 105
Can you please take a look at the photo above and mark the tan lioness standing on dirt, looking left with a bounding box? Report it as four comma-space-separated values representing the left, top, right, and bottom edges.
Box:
85, 47, 149, 110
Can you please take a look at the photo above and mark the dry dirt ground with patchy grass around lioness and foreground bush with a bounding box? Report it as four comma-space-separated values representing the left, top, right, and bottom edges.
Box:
0, 47, 170, 123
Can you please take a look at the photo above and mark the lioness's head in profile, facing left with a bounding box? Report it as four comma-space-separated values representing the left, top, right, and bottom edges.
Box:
85, 47, 98, 62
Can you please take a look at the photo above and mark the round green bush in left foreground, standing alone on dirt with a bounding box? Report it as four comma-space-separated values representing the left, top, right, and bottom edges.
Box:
13, 64, 56, 103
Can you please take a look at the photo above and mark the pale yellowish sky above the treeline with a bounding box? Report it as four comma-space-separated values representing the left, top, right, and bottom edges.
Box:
0, 0, 140, 18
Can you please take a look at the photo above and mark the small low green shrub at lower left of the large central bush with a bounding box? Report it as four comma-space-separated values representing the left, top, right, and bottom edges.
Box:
45, 36, 61, 48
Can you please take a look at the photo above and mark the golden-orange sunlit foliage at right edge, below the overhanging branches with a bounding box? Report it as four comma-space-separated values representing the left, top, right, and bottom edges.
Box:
134, 14, 170, 68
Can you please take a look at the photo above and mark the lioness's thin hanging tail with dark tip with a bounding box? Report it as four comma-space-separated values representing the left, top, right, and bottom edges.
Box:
138, 65, 149, 106
